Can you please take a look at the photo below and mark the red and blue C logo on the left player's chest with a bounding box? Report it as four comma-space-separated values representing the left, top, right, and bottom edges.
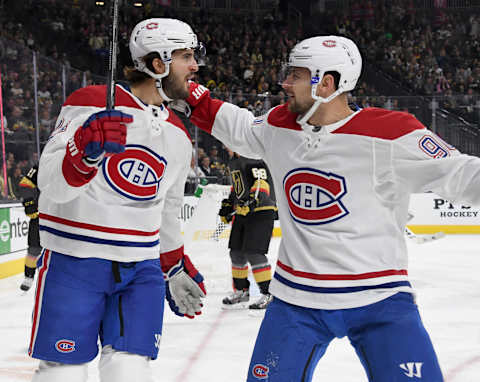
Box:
103, 145, 167, 200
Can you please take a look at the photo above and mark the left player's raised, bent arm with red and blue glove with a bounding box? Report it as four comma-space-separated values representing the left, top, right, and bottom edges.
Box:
38, 109, 133, 202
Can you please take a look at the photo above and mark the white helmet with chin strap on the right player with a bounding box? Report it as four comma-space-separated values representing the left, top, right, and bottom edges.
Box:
288, 36, 362, 124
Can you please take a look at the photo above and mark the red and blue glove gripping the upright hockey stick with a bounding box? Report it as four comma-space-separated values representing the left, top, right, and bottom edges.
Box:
62, 110, 133, 187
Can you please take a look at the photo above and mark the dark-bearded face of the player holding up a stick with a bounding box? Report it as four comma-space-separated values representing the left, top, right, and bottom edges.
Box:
163, 49, 198, 99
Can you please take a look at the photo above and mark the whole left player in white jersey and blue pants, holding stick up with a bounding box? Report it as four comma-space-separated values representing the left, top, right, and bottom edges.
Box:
28, 19, 206, 382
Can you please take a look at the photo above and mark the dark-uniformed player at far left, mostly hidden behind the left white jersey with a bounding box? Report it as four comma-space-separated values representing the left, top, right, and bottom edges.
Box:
19, 165, 42, 291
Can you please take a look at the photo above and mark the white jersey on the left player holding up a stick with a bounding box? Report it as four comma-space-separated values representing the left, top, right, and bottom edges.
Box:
38, 85, 192, 262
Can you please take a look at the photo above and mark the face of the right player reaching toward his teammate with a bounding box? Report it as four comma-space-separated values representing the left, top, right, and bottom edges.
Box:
282, 66, 314, 114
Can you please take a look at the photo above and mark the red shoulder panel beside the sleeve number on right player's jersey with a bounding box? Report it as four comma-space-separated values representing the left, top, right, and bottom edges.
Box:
332, 107, 425, 140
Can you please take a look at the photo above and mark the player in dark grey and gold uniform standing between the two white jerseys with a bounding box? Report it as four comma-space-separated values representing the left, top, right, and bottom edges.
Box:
219, 153, 277, 309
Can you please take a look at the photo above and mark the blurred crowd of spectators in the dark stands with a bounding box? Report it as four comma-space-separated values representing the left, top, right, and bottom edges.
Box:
0, 0, 480, 199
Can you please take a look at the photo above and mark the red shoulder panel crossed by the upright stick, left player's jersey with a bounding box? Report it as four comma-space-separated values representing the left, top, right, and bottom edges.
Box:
63, 85, 142, 110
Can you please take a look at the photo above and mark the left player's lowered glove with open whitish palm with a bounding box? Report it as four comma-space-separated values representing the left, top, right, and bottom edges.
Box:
165, 255, 207, 318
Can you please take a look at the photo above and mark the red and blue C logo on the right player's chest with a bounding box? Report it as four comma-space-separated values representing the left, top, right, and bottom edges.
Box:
283, 168, 349, 225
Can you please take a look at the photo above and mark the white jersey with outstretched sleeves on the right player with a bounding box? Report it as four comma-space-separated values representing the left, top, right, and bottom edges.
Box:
192, 99, 480, 309
